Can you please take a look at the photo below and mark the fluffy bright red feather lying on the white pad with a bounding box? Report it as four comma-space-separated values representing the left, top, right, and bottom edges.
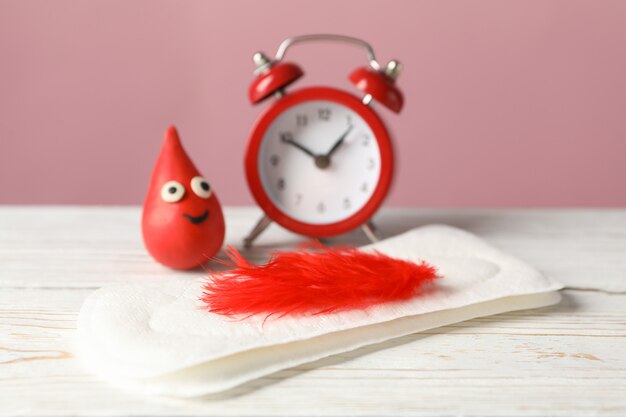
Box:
201, 246, 439, 317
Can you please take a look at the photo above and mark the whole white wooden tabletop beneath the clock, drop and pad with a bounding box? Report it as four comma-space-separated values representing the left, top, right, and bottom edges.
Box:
0, 207, 626, 416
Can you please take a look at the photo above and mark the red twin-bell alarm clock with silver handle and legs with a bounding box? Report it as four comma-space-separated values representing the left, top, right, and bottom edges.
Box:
245, 35, 404, 247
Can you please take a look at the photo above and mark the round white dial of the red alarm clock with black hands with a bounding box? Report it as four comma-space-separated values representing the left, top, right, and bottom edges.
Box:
258, 100, 381, 225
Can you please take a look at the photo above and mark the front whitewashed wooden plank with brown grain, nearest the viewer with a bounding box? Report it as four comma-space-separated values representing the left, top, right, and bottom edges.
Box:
0, 288, 626, 416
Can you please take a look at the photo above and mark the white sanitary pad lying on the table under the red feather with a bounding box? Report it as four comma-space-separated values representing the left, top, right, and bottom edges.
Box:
78, 226, 562, 397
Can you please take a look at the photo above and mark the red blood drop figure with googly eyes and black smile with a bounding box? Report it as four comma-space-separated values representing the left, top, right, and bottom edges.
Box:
141, 126, 224, 269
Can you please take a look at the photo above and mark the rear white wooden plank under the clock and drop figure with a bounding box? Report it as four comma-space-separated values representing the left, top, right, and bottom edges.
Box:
0, 206, 626, 293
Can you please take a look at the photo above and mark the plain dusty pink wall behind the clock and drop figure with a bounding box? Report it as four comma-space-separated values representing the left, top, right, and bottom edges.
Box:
0, 0, 626, 206
